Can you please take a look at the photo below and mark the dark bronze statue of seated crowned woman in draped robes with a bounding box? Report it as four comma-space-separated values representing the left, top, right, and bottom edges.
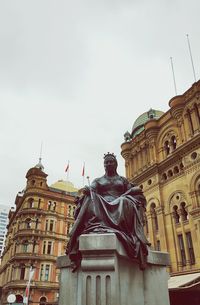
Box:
66, 153, 149, 269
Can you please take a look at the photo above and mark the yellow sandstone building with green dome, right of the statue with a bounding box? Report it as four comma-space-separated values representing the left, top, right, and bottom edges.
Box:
121, 81, 200, 298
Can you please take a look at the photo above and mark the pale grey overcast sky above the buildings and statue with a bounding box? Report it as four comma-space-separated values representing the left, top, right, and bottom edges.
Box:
0, 0, 200, 205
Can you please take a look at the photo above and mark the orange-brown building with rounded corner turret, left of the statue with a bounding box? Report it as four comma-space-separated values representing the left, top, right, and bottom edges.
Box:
0, 162, 77, 305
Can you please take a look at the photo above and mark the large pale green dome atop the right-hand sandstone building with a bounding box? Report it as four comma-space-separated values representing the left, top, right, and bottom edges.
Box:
132, 109, 164, 137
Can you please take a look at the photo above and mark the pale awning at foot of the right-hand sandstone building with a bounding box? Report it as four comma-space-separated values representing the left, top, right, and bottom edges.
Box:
168, 273, 200, 290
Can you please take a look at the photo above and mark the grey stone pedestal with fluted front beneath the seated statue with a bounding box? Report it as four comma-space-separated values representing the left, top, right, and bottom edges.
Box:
57, 233, 169, 305
